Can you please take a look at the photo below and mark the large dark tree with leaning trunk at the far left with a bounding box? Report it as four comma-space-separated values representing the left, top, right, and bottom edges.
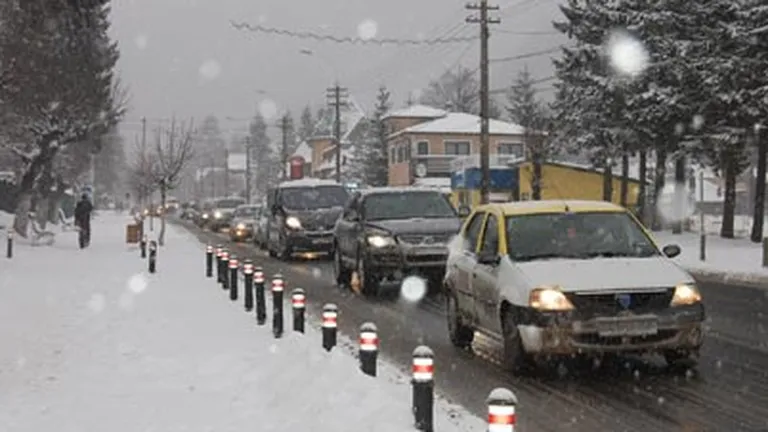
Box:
0, 0, 123, 236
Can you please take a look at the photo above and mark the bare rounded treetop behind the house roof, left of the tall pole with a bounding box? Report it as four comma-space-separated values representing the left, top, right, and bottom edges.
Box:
420, 66, 480, 114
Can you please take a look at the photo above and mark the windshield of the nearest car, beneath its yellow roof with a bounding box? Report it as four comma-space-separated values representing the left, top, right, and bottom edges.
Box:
506, 212, 660, 261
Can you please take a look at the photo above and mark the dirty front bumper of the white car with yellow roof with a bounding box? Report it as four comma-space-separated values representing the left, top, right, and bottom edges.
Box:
518, 304, 705, 355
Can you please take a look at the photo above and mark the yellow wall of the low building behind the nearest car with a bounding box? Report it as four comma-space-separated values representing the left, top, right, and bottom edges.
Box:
520, 163, 639, 207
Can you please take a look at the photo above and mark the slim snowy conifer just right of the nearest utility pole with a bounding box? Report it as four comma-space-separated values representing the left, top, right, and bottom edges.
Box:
507, 66, 552, 200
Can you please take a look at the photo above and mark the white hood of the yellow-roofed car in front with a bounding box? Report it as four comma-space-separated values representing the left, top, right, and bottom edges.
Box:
516, 257, 693, 291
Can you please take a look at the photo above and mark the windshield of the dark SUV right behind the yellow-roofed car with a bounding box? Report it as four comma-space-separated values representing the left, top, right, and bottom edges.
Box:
363, 191, 457, 221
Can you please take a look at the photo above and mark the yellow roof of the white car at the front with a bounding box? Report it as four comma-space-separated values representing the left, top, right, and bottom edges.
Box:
477, 200, 627, 216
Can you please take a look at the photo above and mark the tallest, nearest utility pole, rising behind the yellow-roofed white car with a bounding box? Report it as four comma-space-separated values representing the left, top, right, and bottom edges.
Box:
467, 0, 501, 204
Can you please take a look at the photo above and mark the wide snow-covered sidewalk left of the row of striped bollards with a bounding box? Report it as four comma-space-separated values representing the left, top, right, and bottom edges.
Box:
0, 213, 485, 432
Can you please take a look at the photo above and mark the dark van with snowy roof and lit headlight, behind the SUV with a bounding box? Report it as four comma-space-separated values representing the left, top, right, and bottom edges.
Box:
266, 179, 349, 260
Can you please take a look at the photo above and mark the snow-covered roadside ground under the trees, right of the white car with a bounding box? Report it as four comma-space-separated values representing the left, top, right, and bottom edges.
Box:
652, 231, 768, 288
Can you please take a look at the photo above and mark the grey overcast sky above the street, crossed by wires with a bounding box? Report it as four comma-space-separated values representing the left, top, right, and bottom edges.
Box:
112, 0, 564, 142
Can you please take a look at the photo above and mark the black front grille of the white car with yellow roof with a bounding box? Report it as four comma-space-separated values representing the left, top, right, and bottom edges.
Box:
566, 288, 675, 318
